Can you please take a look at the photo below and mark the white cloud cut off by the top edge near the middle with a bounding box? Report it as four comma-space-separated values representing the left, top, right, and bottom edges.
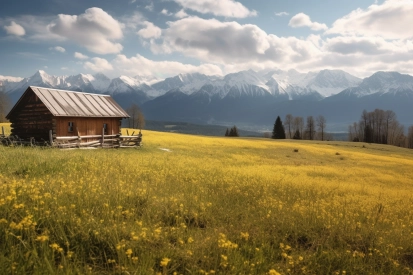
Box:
174, 0, 257, 18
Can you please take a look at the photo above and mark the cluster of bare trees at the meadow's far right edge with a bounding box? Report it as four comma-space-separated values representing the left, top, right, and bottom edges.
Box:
348, 109, 413, 148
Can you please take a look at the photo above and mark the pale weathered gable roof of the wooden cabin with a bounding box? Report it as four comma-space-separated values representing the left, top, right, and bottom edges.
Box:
7, 86, 129, 118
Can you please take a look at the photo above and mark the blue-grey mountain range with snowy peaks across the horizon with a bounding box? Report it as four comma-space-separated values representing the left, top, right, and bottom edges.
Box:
0, 70, 413, 131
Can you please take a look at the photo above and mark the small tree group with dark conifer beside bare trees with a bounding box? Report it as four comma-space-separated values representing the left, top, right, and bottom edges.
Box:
271, 114, 331, 140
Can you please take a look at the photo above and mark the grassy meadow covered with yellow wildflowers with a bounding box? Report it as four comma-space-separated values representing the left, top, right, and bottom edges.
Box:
0, 125, 413, 274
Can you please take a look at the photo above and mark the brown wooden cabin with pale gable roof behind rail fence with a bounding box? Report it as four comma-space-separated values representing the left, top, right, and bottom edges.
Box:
6, 86, 129, 141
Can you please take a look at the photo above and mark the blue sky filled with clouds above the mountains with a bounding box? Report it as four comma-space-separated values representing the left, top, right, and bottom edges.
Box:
0, 0, 413, 78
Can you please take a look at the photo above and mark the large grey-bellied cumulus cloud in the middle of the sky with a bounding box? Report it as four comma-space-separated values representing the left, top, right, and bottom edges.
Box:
151, 17, 318, 64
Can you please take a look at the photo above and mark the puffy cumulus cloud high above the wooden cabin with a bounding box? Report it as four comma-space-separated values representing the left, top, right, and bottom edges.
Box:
48, 8, 123, 54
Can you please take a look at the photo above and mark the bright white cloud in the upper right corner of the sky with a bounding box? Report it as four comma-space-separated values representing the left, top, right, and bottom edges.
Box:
326, 0, 413, 39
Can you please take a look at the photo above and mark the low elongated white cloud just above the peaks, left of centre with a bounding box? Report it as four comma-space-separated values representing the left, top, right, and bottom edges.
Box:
112, 54, 222, 78
